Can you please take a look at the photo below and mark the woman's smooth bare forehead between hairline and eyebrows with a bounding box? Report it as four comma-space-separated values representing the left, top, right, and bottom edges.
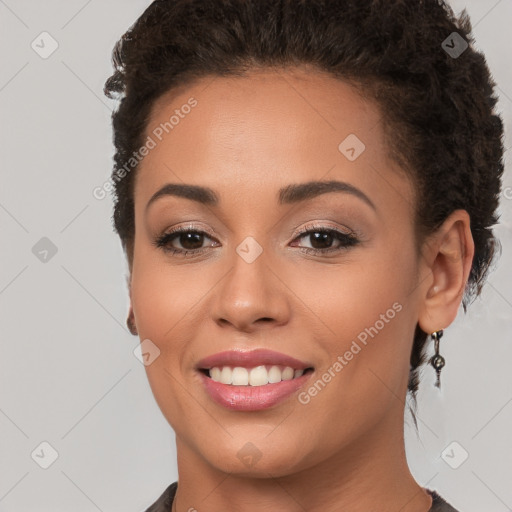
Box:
136, 68, 407, 214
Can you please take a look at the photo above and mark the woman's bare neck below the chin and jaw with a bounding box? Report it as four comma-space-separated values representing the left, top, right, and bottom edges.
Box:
173, 408, 432, 512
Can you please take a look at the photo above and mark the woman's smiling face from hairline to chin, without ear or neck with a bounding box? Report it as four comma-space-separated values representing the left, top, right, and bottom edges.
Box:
130, 69, 419, 475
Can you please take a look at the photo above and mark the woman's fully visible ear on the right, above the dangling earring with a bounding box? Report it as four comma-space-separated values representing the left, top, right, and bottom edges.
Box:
418, 210, 475, 333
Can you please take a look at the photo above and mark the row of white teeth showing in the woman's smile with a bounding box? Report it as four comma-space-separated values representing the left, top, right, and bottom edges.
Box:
209, 365, 304, 386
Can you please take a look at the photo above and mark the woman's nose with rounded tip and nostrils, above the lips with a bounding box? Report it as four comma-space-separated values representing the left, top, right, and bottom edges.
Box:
213, 247, 291, 332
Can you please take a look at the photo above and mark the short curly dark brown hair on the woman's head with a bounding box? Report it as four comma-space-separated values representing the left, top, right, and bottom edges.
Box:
105, 0, 503, 414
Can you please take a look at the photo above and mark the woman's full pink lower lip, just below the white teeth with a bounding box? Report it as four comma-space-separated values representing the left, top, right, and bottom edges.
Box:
199, 371, 313, 411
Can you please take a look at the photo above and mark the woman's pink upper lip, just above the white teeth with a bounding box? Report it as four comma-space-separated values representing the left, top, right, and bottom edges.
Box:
196, 349, 313, 370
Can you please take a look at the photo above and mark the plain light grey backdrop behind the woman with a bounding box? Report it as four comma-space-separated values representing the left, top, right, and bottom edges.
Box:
0, 0, 512, 512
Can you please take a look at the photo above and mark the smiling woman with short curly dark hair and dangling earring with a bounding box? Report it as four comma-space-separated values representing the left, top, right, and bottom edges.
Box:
105, 0, 503, 512
